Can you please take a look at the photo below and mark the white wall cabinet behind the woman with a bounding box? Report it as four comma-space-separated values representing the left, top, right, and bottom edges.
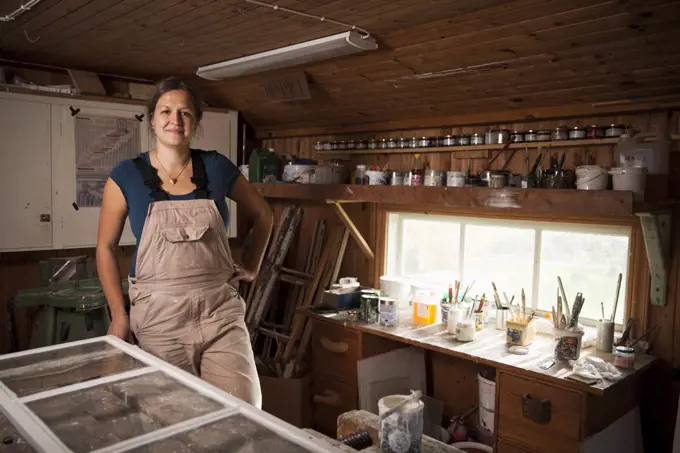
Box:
0, 93, 237, 252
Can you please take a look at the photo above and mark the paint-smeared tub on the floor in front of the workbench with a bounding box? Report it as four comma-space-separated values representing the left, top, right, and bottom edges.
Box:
378, 395, 425, 453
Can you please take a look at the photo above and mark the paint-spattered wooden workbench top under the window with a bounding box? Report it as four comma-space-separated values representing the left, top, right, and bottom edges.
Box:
301, 309, 656, 395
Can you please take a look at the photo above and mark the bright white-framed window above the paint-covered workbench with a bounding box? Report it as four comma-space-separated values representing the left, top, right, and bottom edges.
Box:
385, 212, 631, 324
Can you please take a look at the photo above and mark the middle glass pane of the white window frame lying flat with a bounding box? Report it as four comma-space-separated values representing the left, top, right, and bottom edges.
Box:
27, 371, 224, 453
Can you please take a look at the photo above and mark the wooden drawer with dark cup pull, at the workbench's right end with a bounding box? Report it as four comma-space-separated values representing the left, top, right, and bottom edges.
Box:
497, 372, 583, 453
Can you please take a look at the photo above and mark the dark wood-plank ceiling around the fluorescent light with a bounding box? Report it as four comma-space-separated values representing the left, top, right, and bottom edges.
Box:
0, 0, 680, 130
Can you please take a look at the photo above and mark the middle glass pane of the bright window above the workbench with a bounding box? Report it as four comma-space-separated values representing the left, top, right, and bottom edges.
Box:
461, 224, 535, 306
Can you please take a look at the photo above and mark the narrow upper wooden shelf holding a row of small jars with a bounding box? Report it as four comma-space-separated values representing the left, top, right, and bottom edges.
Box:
315, 138, 619, 156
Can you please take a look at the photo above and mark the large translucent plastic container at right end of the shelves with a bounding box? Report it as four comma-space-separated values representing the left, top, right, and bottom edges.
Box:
614, 133, 670, 175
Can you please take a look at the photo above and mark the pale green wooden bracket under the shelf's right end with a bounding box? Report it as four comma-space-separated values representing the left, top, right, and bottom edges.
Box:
636, 210, 672, 307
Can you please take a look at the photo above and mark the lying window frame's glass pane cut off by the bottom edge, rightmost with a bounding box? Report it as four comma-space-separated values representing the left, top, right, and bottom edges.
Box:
130, 414, 316, 453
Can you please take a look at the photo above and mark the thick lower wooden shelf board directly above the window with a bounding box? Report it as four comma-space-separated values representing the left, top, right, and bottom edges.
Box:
254, 183, 649, 217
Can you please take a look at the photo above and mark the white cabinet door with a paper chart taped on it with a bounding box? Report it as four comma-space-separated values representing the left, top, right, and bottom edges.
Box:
52, 102, 149, 248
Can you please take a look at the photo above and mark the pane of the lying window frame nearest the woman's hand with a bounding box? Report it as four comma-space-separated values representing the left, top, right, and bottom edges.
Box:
0, 341, 146, 397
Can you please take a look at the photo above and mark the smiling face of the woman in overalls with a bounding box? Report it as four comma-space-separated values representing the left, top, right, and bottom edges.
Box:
151, 90, 198, 148
